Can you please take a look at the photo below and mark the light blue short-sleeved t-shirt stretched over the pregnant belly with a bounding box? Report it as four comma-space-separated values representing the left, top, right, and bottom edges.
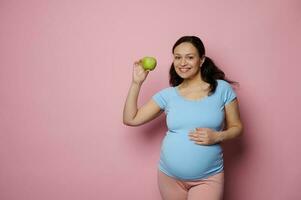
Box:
152, 80, 236, 180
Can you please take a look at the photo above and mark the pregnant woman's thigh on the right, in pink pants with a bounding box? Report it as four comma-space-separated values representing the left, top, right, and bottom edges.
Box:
187, 172, 224, 200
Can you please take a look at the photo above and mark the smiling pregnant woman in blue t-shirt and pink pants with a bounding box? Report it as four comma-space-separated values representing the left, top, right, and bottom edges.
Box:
123, 36, 243, 200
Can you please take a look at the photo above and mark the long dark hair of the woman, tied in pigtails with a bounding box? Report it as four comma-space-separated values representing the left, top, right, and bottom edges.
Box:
169, 36, 237, 95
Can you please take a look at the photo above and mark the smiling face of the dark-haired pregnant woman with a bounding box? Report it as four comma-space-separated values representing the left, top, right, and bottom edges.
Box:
173, 42, 202, 79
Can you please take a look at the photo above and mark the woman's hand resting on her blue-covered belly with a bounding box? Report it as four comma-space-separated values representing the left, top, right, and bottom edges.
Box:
188, 128, 218, 145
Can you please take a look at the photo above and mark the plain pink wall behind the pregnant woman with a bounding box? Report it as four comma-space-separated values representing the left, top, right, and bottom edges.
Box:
0, 0, 301, 200
